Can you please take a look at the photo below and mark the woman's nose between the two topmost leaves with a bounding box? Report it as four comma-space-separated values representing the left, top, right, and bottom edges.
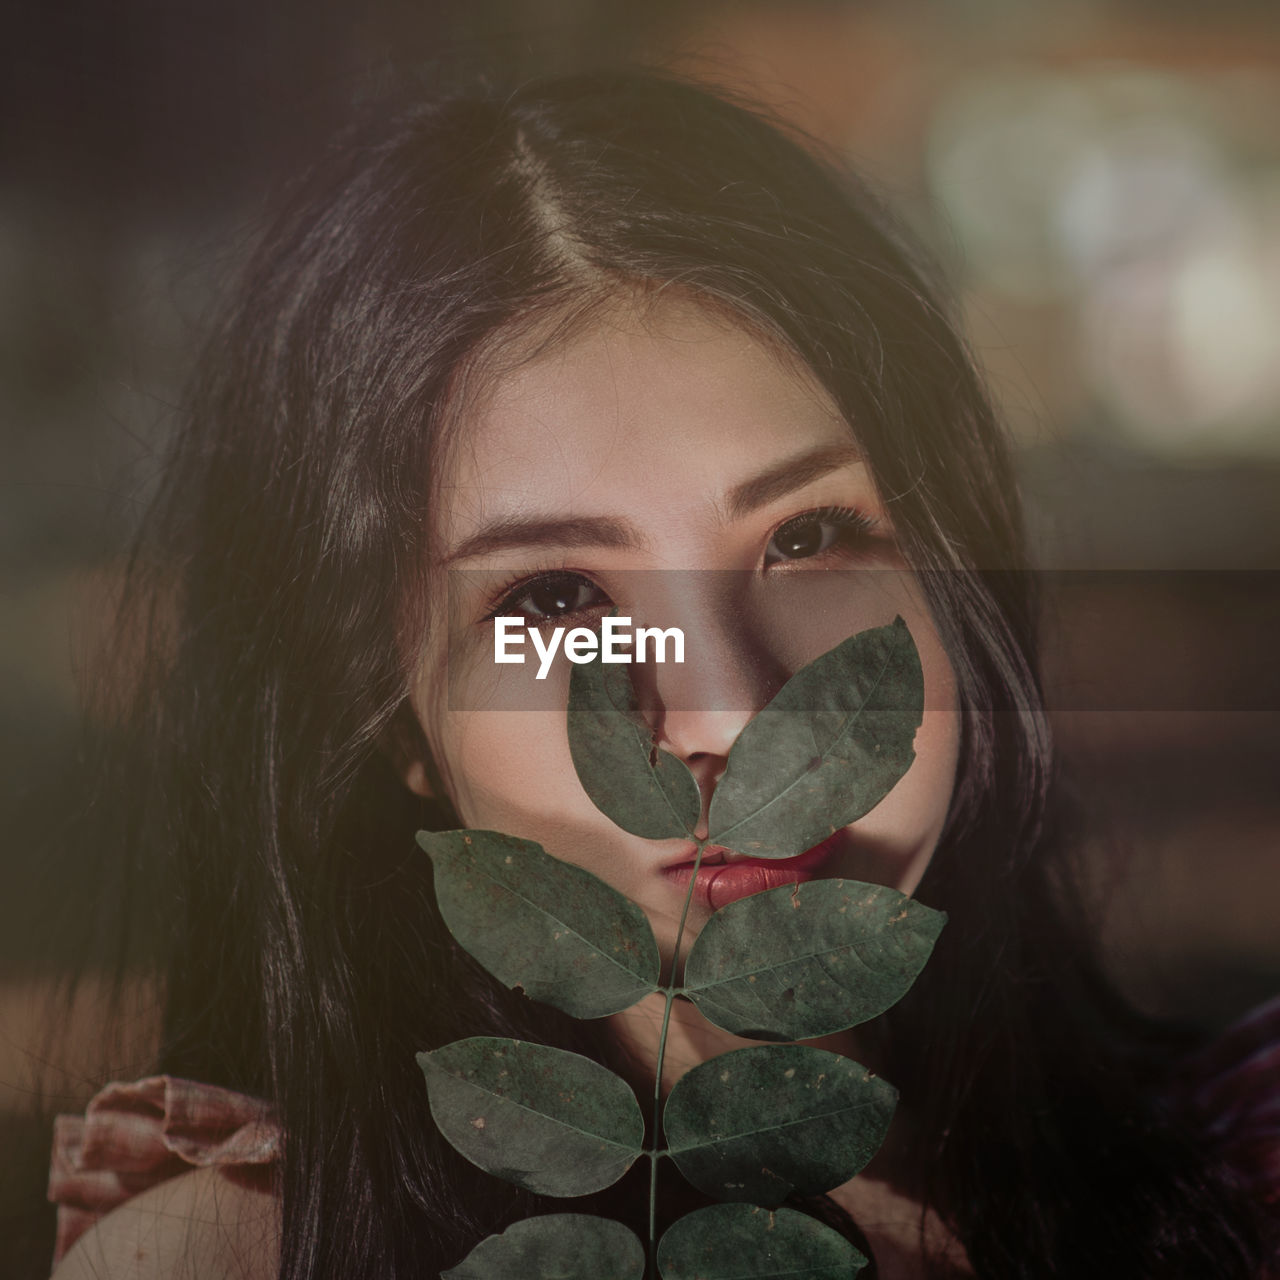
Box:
632, 593, 788, 837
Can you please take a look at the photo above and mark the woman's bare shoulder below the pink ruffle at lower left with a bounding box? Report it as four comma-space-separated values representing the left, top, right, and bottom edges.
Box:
52, 1169, 279, 1280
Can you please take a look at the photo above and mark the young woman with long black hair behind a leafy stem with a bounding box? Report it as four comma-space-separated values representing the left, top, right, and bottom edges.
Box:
45, 76, 1276, 1280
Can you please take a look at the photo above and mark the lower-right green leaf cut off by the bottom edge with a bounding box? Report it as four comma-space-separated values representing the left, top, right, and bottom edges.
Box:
660, 1204, 867, 1280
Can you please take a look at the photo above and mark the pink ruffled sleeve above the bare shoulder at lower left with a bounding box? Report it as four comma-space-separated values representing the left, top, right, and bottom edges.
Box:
49, 1075, 283, 1267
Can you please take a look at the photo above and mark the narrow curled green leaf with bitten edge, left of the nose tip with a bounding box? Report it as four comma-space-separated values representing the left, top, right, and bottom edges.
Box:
568, 658, 703, 840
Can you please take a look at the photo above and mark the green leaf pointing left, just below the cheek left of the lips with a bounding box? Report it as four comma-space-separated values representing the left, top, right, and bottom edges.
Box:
417, 831, 659, 1018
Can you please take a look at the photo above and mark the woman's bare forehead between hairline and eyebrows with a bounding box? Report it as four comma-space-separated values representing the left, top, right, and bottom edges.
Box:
433, 297, 850, 549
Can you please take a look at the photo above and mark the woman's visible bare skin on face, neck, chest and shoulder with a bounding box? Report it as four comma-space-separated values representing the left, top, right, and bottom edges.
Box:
55, 293, 966, 1280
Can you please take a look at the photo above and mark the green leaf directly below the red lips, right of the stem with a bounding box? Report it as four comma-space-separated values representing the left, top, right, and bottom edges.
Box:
684, 879, 946, 1041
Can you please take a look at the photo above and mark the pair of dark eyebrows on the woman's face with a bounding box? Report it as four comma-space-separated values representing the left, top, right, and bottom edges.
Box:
443, 442, 863, 566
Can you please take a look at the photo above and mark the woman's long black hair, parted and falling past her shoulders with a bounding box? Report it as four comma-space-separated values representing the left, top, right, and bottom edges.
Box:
87, 73, 1261, 1280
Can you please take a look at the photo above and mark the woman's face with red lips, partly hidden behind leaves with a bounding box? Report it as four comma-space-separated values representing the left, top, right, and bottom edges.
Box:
404, 297, 959, 955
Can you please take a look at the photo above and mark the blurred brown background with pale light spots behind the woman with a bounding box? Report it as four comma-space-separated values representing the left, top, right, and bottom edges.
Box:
0, 0, 1280, 1277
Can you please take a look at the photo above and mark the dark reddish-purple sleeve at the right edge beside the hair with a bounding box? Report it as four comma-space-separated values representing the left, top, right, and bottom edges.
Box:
1174, 997, 1280, 1207
